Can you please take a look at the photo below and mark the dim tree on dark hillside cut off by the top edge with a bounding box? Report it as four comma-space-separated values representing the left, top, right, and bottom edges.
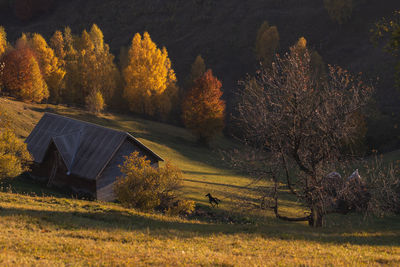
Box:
324, 0, 353, 24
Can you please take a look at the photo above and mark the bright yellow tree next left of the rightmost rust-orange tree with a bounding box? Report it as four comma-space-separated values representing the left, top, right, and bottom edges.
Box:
123, 32, 176, 116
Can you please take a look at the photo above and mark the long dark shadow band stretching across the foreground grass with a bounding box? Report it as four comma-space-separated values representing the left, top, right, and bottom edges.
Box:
0, 205, 400, 249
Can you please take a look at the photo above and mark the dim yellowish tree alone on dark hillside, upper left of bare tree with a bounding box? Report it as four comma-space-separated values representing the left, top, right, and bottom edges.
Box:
255, 21, 279, 67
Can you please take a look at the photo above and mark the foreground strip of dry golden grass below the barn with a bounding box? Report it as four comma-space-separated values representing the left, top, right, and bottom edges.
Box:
0, 193, 400, 266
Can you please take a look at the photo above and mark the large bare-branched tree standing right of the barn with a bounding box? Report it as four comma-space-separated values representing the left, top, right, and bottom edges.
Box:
232, 44, 372, 227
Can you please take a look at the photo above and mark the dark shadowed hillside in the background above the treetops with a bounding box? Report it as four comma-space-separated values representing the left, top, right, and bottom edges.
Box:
0, 0, 400, 149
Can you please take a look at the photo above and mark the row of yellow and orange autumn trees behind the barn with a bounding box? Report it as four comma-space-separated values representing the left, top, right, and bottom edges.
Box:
0, 25, 225, 146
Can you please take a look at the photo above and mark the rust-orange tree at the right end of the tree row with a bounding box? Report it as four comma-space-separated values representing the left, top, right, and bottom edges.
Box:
182, 70, 225, 145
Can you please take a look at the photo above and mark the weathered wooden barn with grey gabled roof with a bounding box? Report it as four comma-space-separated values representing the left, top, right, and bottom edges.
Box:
25, 113, 163, 201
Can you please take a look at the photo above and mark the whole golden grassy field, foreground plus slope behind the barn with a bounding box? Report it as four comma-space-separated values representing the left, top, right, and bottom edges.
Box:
0, 99, 400, 266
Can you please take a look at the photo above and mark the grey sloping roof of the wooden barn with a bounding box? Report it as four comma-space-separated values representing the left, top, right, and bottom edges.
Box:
25, 113, 163, 179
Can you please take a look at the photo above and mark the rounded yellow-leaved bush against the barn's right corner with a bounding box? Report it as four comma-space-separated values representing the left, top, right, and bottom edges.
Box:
114, 152, 194, 215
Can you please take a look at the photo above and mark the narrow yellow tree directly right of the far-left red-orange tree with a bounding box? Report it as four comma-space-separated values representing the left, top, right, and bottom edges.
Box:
28, 33, 66, 103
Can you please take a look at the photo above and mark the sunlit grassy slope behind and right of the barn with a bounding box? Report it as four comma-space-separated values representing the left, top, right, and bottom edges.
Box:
0, 98, 268, 208
